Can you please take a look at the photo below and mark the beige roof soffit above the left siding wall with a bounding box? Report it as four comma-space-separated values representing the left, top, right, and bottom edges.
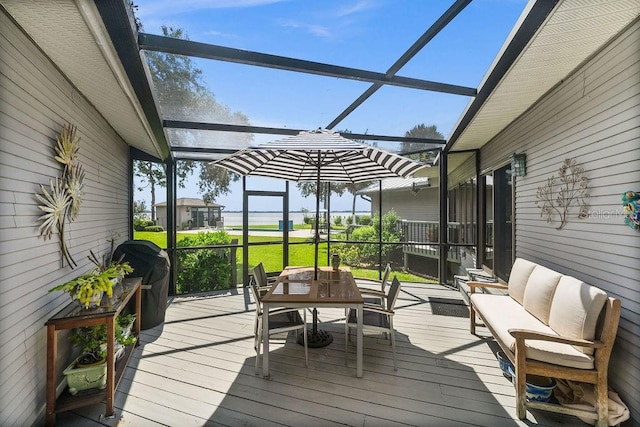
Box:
3, 0, 168, 157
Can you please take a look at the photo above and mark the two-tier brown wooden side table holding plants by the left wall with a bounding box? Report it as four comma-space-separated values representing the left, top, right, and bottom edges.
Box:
45, 277, 142, 426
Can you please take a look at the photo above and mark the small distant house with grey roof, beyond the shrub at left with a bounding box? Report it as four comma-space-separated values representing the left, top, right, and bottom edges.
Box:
154, 197, 224, 230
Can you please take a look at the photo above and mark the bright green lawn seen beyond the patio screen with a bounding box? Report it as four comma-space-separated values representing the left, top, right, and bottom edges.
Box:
133, 231, 426, 282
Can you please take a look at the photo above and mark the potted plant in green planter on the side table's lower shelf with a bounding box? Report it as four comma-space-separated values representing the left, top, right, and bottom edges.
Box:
63, 314, 137, 395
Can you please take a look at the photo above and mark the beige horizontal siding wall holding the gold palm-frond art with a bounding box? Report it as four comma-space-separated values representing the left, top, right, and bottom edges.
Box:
0, 12, 129, 425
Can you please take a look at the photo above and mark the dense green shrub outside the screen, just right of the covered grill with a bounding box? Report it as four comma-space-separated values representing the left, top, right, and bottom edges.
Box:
176, 230, 234, 293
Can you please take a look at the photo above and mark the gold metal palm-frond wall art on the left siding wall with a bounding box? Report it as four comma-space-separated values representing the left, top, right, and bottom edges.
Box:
36, 124, 84, 268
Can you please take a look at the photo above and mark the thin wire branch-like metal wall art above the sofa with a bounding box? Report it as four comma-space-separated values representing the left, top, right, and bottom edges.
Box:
536, 159, 589, 230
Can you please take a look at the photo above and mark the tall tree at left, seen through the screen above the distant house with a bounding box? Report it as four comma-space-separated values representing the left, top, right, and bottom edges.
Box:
134, 26, 253, 214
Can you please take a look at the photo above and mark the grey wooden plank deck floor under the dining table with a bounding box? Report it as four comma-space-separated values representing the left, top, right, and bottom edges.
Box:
57, 283, 585, 427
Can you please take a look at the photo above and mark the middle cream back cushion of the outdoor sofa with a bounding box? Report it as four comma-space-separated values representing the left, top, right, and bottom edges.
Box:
522, 265, 562, 325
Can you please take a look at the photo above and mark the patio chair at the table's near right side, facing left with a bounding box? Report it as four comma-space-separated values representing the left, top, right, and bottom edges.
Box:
344, 276, 400, 371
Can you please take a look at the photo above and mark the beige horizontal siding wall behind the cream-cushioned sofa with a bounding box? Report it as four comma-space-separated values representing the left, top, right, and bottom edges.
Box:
481, 21, 640, 423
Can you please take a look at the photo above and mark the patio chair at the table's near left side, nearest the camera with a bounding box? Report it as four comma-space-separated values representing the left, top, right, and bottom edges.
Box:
249, 280, 309, 375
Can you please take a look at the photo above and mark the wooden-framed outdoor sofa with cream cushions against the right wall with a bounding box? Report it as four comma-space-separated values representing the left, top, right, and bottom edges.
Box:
467, 258, 620, 426
